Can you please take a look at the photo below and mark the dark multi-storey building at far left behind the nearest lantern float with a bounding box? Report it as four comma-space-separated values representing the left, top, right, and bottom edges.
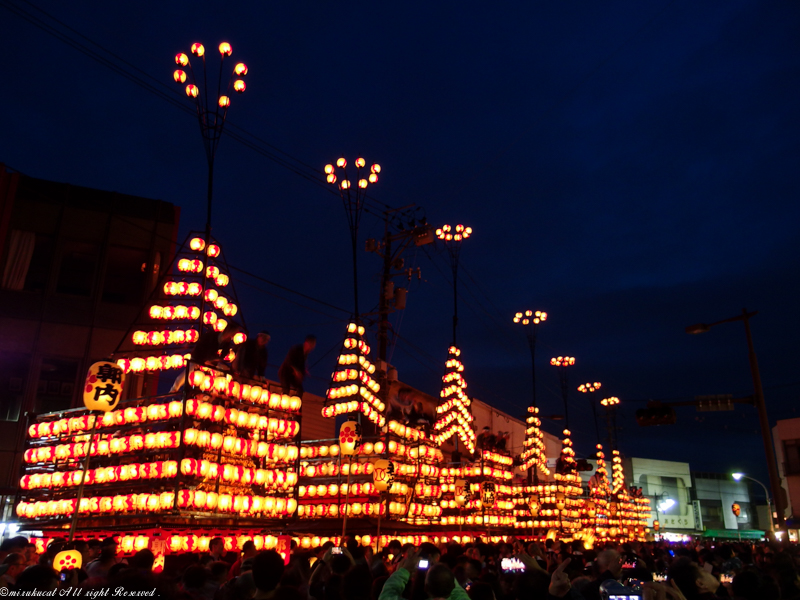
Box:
0, 165, 180, 516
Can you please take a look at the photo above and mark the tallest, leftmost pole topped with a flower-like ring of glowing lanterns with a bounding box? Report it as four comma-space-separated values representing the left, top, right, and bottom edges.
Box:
172, 42, 248, 239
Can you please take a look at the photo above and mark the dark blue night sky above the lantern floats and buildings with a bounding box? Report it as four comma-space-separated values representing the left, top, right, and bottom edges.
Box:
0, 0, 800, 480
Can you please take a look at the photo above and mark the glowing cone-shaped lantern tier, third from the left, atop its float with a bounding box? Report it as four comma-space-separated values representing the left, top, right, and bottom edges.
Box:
433, 346, 475, 454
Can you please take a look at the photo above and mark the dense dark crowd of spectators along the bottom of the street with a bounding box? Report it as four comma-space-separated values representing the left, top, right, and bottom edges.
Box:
0, 537, 800, 600
